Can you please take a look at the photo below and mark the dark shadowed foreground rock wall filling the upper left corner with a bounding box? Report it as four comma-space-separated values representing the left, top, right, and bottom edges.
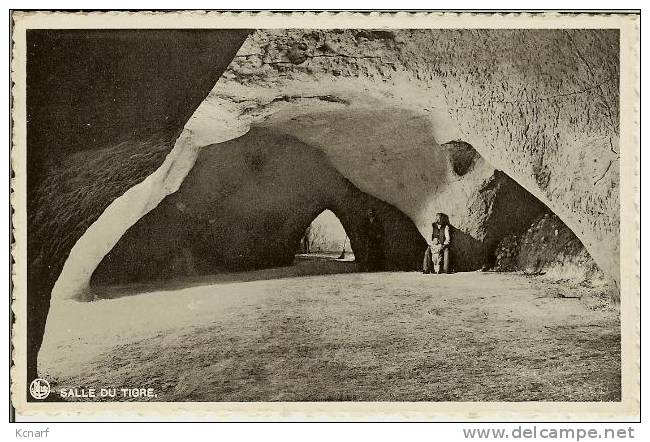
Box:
27, 30, 247, 383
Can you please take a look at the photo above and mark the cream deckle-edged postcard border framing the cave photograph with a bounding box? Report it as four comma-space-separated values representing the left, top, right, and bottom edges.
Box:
11, 11, 640, 421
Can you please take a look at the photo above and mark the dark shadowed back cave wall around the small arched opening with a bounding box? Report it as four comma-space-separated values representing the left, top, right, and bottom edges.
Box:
92, 128, 426, 284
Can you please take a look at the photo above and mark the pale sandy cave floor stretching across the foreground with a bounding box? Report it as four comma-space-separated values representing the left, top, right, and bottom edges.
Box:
39, 262, 621, 401
